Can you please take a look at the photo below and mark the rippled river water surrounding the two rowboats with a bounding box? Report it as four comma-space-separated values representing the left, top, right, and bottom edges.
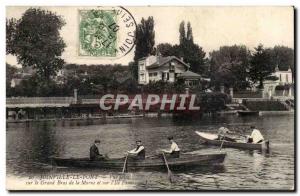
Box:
6, 115, 294, 190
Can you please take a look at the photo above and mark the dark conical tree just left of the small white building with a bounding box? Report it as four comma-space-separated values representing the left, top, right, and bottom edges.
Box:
249, 44, 274, 89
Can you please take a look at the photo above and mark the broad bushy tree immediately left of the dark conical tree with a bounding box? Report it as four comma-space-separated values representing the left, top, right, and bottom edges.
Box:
210, 45, 251, 90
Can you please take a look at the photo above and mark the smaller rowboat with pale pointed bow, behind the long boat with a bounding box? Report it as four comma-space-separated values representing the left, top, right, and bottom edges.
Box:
196, 131, 269, 150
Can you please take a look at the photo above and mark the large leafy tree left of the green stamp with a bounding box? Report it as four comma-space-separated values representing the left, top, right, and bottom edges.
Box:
7, 8, 66, 82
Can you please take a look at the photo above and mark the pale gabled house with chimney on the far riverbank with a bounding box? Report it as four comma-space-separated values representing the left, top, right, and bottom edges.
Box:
138, 55, 206, 85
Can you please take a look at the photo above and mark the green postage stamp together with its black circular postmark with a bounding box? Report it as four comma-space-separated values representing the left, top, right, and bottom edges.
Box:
79, 7, 137, 59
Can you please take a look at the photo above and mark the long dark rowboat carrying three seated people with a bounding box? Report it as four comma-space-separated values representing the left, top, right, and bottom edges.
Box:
52, 152, 226, 170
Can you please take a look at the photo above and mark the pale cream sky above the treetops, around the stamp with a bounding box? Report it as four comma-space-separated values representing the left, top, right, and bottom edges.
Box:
6, 6, 294, 66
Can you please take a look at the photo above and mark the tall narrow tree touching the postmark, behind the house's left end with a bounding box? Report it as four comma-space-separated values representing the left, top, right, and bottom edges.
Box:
134, 16, 155, 65
